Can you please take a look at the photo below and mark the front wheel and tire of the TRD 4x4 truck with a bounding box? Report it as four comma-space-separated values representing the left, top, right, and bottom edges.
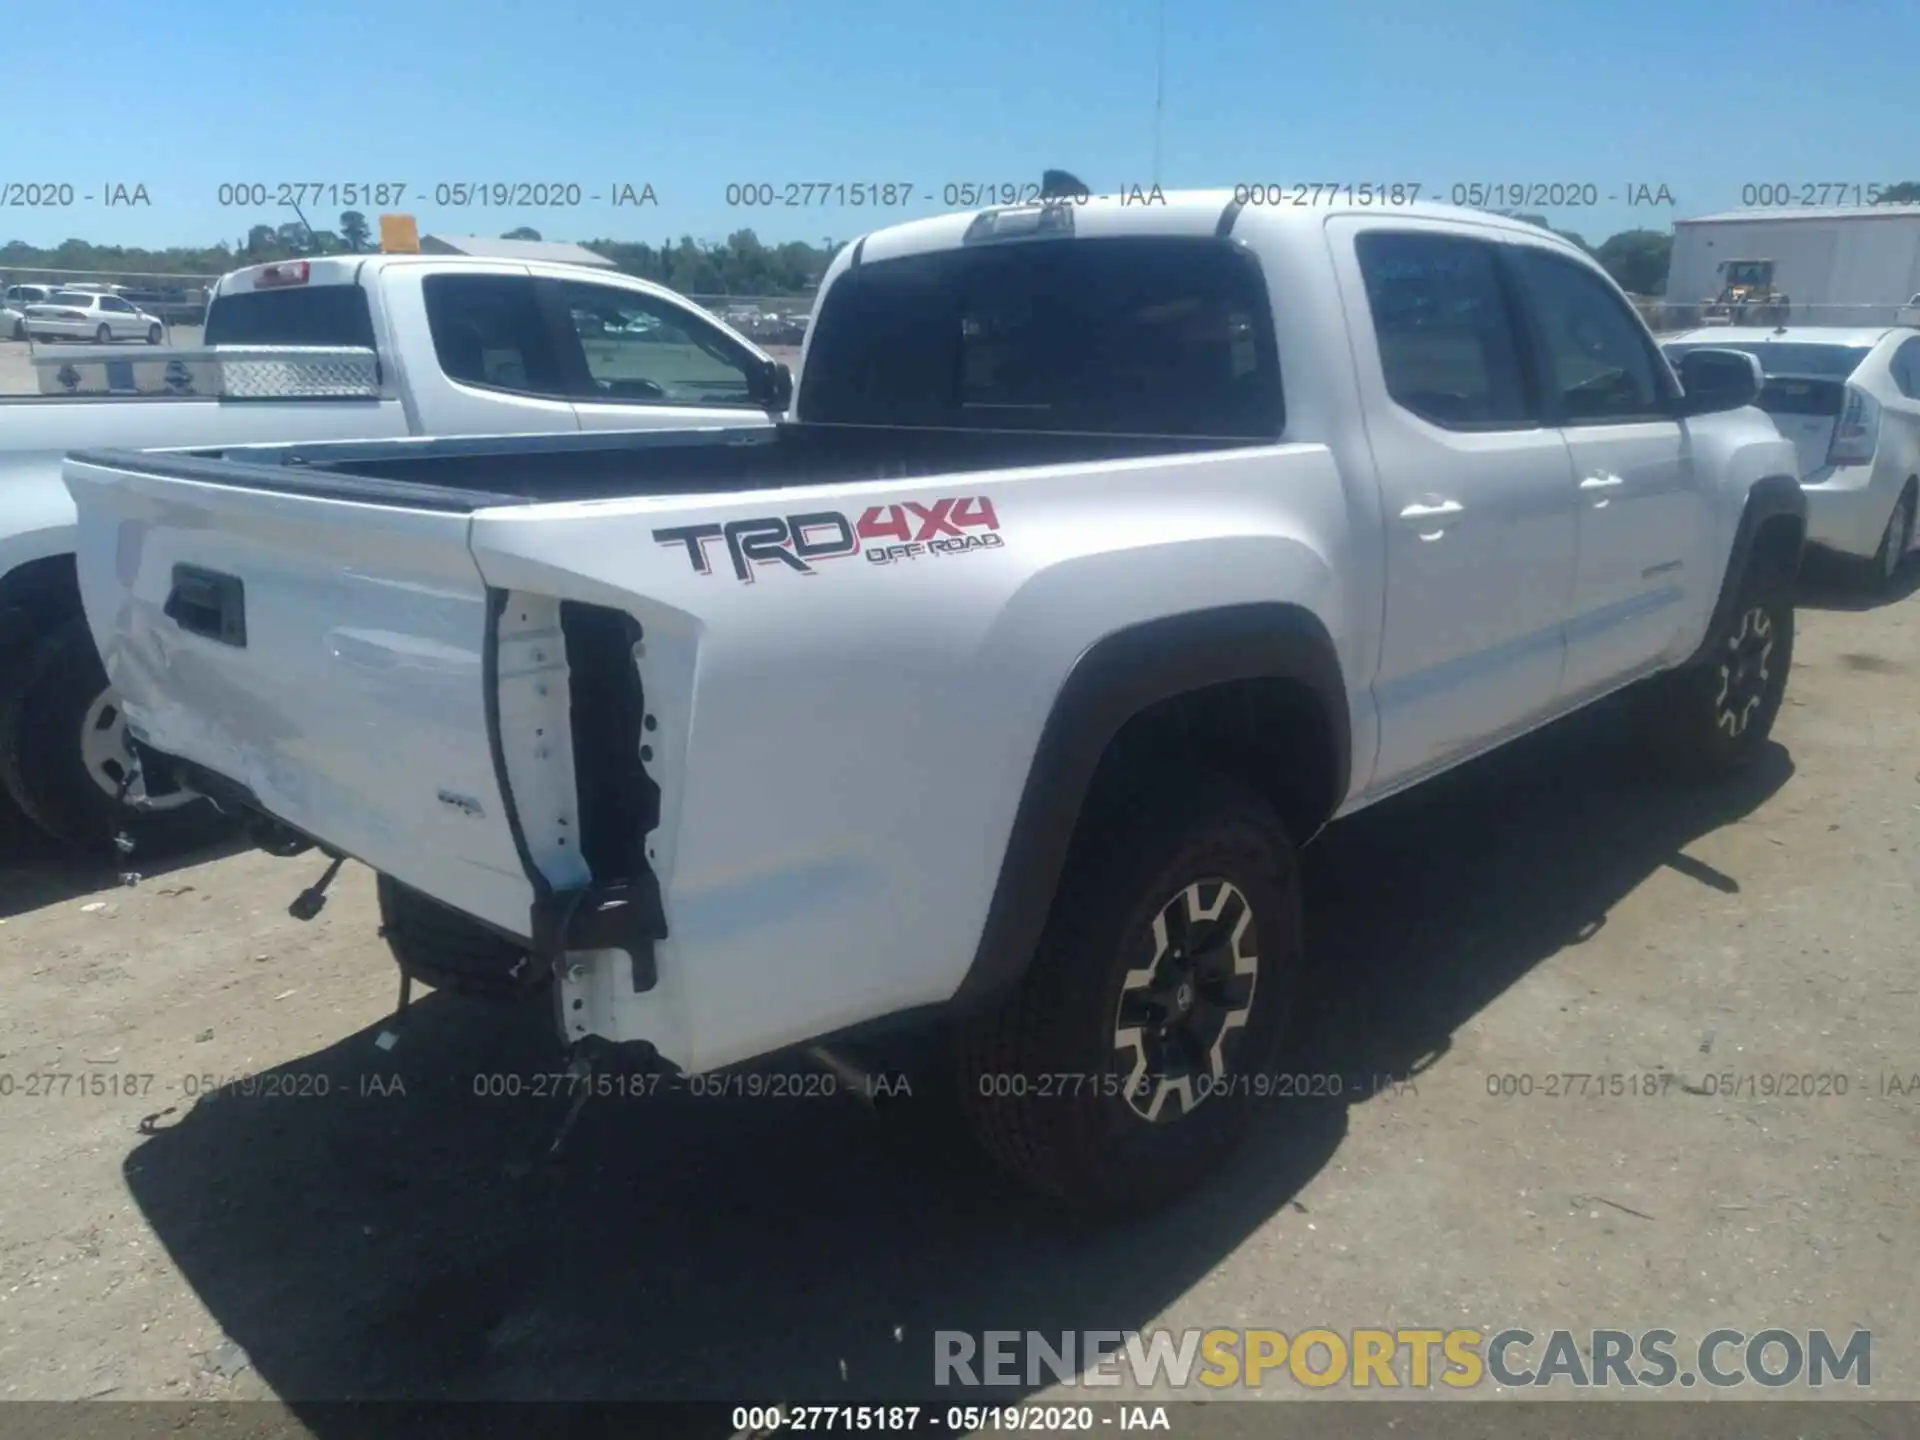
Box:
1645, 566, 1793, 780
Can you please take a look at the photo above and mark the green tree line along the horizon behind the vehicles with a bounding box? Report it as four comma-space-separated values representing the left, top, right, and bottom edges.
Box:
11, 183, 1920, 296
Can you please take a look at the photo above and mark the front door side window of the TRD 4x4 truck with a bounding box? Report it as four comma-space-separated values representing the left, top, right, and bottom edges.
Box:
1511, 246, 1670, 424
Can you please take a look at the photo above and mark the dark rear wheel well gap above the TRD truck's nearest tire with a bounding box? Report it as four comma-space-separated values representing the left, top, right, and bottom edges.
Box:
1083, 678, 1342, 845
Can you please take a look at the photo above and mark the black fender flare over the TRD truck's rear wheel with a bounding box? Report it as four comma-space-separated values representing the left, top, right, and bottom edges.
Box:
950, 603, 1354, 1014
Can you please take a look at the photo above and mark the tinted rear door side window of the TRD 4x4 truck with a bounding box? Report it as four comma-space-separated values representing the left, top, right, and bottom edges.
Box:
1354, 230, 1540, 430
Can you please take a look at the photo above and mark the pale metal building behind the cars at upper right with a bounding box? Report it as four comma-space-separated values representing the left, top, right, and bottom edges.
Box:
1667, 205, 1920, 324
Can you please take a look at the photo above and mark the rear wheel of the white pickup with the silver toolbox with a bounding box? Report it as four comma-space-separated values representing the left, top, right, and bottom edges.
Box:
0, 616, 228, 851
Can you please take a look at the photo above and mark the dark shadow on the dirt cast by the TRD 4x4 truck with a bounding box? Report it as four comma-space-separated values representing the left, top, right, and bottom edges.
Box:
125, 708, 1791, 1436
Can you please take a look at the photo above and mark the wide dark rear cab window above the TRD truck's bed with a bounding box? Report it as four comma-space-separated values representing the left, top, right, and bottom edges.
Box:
801, 236, 1284, 440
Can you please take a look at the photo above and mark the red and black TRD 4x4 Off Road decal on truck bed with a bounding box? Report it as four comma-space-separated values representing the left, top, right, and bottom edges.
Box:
653, 495, 1004, 586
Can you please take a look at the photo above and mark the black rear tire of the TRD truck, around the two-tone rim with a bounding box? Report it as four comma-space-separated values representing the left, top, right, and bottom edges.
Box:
956, 770, 1302, 1213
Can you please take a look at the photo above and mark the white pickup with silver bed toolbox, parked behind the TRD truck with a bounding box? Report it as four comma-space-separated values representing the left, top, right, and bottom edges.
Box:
0, 255, 791, 845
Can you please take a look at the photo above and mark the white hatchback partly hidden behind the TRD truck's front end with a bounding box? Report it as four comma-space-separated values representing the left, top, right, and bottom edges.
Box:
1661, 324, 1920, 591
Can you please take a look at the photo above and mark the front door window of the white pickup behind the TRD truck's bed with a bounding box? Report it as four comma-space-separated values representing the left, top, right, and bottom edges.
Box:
561, 280, 753, 405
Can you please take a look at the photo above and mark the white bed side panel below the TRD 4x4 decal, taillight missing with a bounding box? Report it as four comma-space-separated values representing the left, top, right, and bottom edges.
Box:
472, 445, 1348, 1069
